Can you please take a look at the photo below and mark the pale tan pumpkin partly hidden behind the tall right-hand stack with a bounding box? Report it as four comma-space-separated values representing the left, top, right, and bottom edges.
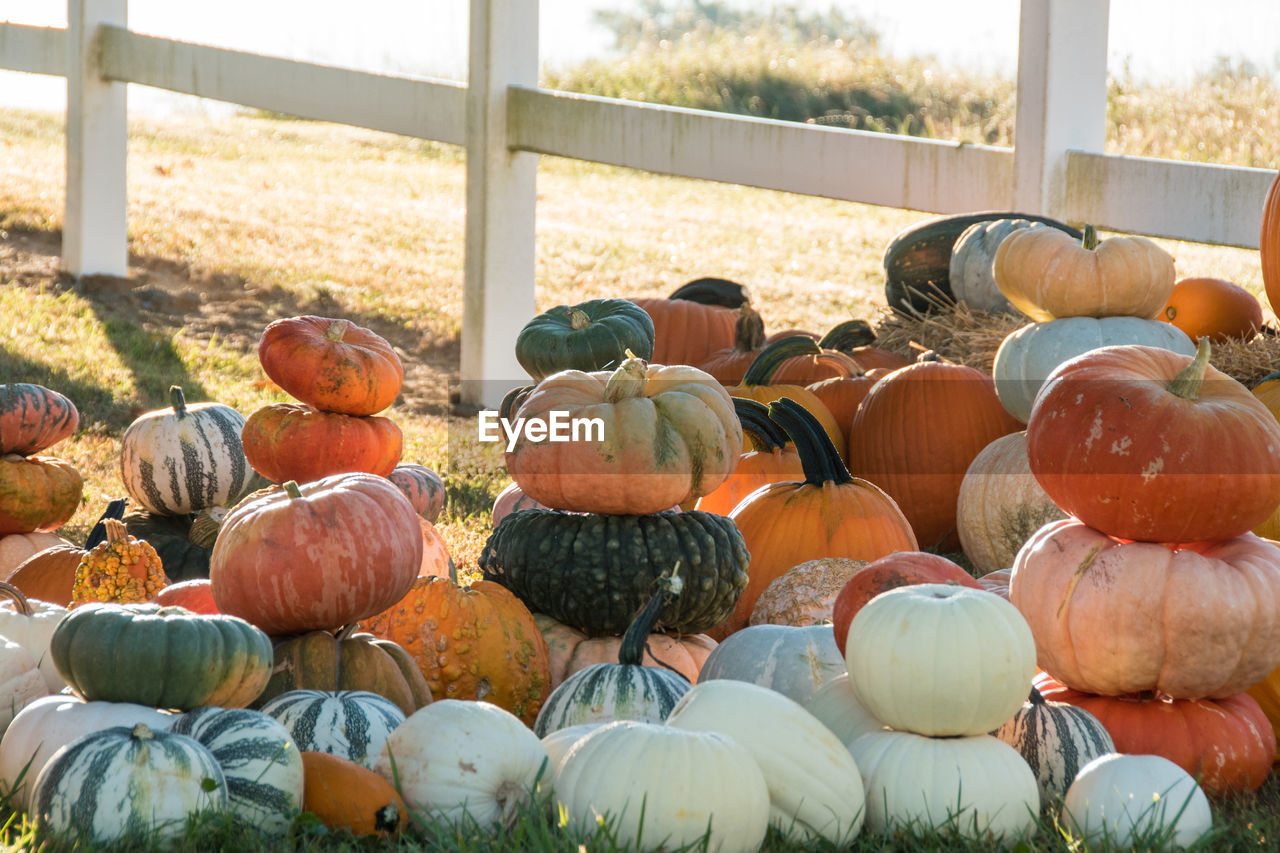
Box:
956, 427, 1066, 575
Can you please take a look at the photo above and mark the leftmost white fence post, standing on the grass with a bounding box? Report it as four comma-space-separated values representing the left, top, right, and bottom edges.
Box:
63, 0, 129, 277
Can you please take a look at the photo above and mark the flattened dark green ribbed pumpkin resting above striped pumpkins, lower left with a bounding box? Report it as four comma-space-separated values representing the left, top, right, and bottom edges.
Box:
49, 603, 271, 711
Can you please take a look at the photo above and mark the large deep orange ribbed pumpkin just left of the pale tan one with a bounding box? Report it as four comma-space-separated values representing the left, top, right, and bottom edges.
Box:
849, 352, 1021, 551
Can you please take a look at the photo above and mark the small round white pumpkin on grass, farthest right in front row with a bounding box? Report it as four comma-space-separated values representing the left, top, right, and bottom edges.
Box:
1062, 753, 1213, 849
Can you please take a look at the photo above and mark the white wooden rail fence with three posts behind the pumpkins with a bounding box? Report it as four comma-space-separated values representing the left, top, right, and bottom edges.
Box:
0, 0, 1276, 405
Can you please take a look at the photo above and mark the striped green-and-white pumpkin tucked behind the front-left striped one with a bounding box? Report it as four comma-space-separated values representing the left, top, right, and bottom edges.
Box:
169, 706, 303, 835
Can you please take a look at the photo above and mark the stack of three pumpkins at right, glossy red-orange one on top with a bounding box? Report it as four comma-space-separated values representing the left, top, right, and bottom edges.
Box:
1009, 339, 1280, 793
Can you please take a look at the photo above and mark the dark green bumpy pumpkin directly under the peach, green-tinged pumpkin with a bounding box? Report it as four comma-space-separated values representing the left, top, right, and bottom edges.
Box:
479, 510, 754, 635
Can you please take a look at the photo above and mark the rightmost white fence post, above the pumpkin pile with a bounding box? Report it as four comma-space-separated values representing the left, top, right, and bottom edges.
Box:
1014, 0, 1110, 216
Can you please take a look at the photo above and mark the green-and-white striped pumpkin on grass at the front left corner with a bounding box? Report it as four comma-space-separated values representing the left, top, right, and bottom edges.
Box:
32, 722, 227, 844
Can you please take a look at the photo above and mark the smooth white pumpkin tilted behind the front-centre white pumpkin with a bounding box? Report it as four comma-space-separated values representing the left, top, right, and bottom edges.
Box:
667, 679, 865, 848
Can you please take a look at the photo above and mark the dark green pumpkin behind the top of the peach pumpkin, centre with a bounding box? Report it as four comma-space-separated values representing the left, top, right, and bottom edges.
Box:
516, 300, 653, 380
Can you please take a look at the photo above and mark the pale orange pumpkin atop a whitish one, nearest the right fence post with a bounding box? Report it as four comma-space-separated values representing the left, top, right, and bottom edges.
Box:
992, 225, 1176, 323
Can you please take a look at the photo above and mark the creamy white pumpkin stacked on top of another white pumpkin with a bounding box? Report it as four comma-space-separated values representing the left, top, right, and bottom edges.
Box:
845, 584, 1036, 736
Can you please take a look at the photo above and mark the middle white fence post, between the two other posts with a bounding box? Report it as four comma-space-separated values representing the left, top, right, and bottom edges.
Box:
461, 0, 538, 407
